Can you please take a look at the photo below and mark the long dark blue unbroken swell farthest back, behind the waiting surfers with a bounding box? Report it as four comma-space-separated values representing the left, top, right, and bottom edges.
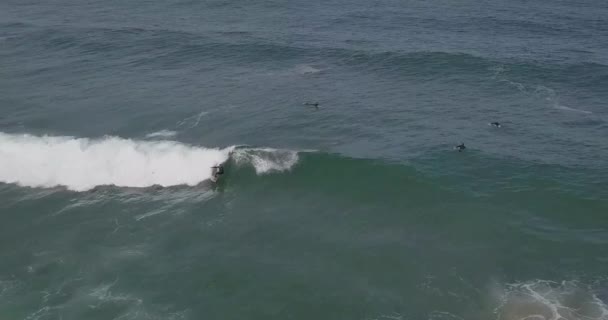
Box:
5, 23, 608, 88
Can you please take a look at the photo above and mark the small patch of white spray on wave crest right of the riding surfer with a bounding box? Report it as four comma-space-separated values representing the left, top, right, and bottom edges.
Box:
233, 148, 298, 174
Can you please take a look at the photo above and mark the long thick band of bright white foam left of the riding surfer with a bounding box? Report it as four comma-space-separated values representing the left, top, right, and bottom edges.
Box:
0, 133, 232, 191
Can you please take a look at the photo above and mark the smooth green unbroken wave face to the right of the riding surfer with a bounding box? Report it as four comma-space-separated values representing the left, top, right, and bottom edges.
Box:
220, 148, 608, 240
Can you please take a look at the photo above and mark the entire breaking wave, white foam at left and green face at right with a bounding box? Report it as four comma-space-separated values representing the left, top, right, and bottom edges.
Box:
0, 133, 608, 250
